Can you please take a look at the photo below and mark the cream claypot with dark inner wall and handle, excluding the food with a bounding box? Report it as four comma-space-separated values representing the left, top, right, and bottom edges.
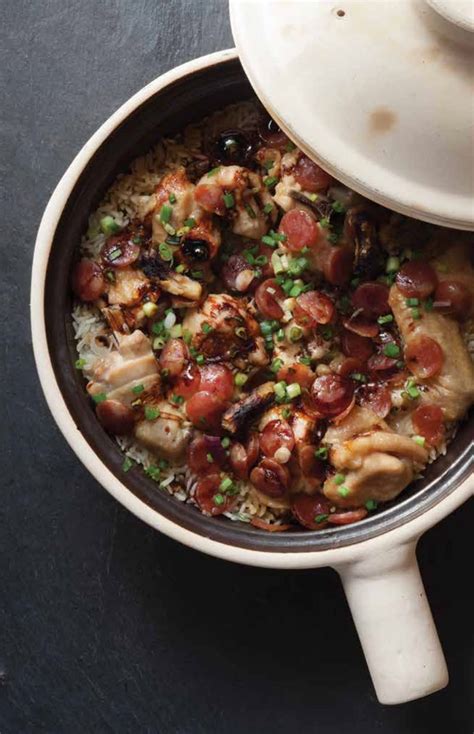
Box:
31, 50, 474, 703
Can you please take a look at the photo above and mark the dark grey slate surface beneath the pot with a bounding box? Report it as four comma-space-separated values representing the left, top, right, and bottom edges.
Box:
0, 0, 474, 734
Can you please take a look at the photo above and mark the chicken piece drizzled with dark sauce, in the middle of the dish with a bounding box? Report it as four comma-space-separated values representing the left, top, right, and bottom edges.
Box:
183, 294, 269, 366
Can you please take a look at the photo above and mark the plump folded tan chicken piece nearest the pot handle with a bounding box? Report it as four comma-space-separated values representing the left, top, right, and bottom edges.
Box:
323, 407, 428, 508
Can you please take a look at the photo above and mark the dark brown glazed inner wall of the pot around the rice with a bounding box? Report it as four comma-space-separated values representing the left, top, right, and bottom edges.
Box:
44, 59, 474, 552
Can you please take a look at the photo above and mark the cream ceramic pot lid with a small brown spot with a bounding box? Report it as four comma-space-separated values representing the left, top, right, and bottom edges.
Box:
230, 0, 474, 229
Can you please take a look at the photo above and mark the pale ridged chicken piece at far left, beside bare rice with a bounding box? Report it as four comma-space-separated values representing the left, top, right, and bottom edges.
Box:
87, 329, 160, 405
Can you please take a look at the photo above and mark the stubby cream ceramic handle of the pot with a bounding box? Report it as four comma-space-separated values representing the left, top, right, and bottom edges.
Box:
336, 541, 448, 704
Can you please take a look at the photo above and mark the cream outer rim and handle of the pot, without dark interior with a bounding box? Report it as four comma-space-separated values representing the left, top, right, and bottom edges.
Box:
31, 50, 474, 703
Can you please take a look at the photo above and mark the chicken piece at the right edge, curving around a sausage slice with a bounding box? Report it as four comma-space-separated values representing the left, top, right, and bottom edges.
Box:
389, 285, 474, 421
